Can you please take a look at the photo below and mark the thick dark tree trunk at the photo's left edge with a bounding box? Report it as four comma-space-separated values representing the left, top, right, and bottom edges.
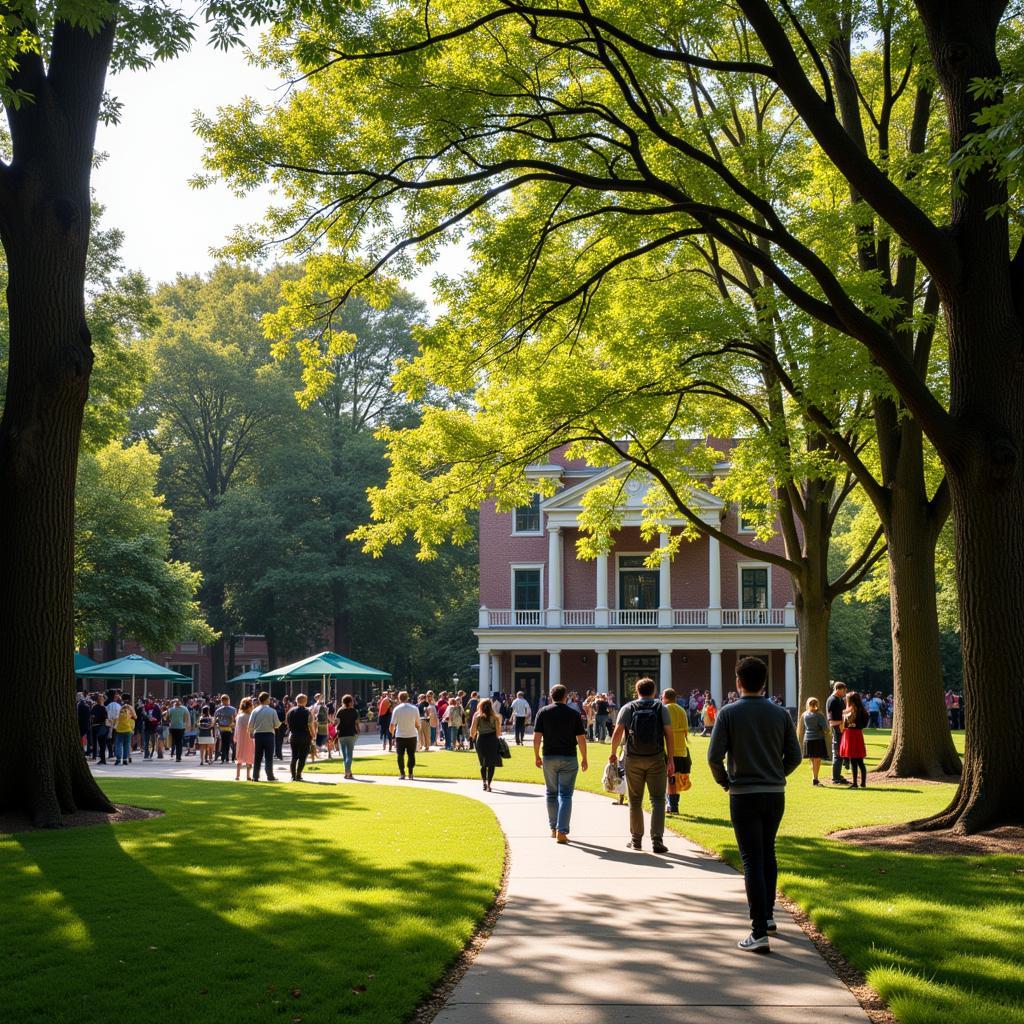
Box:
0, 20, 114, 826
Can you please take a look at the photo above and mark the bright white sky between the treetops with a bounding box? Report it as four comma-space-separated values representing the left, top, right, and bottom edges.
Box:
92, 36, 457, 304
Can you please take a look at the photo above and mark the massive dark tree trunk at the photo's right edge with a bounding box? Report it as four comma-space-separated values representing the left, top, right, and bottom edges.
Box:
916, 0, 1024, 833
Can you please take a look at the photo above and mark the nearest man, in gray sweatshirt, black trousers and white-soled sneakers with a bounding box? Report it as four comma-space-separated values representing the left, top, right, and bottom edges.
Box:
708, 657, 801, 953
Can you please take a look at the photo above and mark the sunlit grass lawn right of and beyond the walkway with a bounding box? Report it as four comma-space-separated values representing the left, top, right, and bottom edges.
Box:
317, 730, 1024, 1024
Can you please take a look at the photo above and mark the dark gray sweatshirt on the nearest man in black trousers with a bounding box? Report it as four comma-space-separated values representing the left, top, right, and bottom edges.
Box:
708, 696, 801, 796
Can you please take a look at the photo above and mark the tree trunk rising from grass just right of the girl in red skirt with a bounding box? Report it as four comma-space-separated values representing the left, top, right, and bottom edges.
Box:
879, 420, 961, 778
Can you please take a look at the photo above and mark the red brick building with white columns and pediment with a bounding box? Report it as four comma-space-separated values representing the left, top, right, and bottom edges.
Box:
475, 452, 798, 708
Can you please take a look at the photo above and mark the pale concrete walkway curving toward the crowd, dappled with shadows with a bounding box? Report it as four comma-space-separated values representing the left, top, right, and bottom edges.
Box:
96, 743, 867, 1024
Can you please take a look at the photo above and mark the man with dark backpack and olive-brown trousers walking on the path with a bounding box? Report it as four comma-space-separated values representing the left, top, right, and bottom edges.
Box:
608, 677, 676, 853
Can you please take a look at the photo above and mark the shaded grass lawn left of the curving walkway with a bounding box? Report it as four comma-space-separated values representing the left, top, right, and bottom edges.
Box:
0, 779, 504, 1024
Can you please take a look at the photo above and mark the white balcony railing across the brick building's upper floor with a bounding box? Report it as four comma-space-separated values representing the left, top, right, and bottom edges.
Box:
480, 605, 796, 629
